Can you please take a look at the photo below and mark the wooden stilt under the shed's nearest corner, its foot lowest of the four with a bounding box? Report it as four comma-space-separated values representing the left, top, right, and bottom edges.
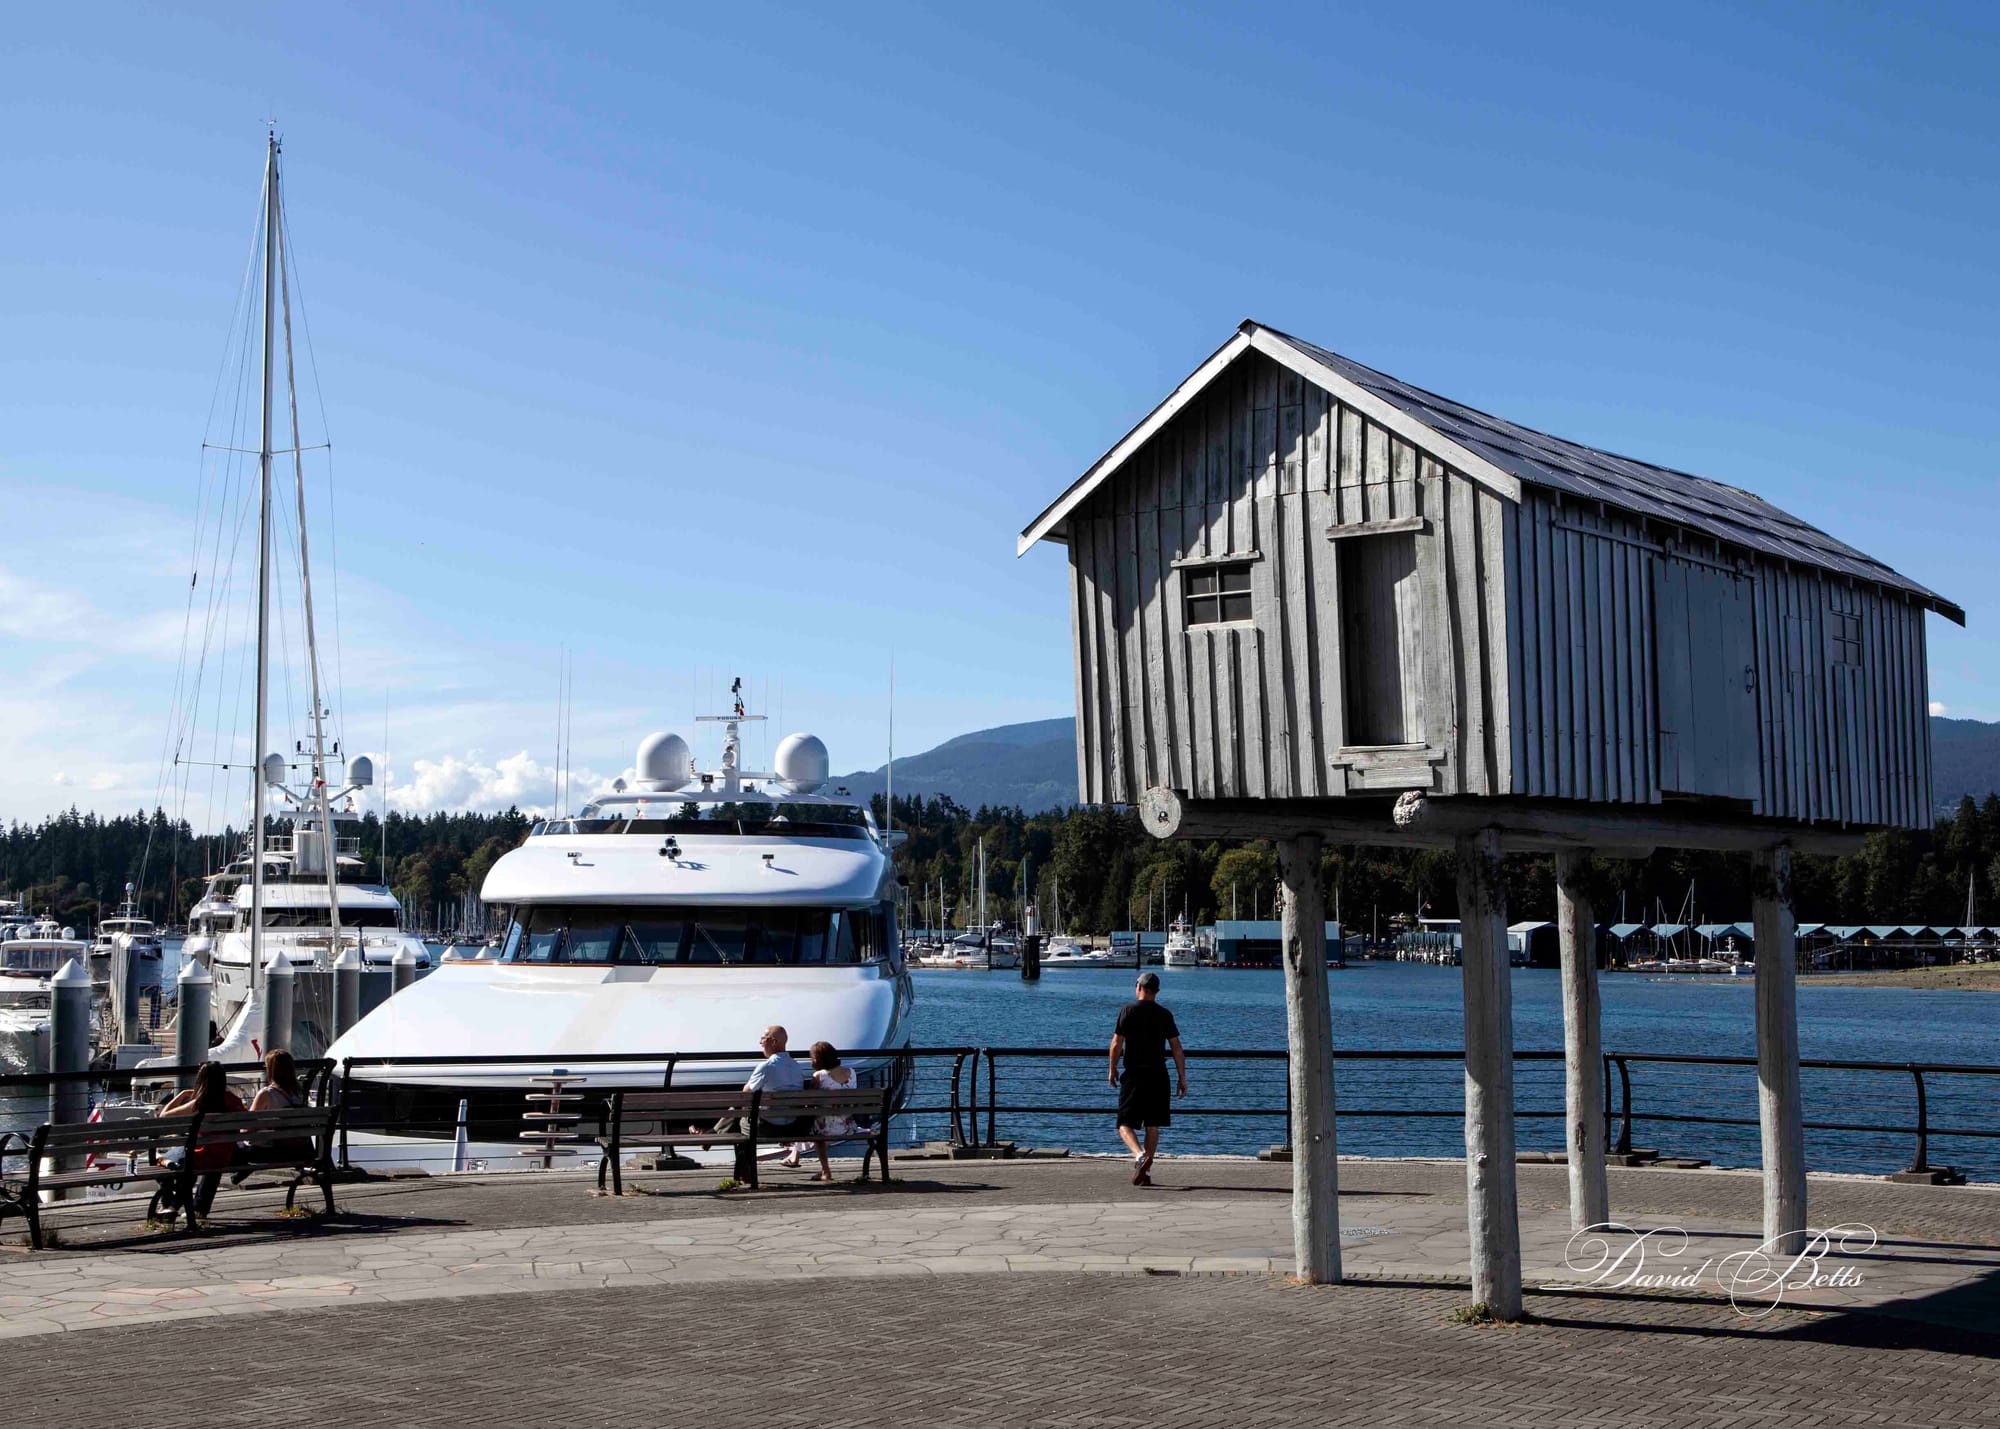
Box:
1458, 829, 1520, 1319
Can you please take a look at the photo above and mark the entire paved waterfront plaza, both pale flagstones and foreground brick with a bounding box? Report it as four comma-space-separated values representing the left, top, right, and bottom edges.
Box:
0, 1159, 2000, 1425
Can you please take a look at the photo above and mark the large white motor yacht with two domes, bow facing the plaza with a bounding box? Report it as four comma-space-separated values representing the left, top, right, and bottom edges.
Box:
328, 698, 914, 1141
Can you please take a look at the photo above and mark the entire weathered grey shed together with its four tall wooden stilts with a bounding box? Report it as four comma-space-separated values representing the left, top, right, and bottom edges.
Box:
1020, 322, 1964, 1315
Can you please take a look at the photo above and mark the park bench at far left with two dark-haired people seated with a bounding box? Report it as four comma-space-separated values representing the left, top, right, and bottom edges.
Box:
0, 1107, 336, 1251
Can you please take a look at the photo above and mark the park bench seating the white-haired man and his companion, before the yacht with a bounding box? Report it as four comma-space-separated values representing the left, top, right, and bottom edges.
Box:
598, 1087, 890, 1195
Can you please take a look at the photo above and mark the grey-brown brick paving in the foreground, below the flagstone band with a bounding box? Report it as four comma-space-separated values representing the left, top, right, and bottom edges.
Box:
0, 1275, 2000, 1429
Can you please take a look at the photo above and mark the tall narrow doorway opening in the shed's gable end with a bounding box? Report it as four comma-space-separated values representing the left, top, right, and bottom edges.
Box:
1338, 532, 1424, 747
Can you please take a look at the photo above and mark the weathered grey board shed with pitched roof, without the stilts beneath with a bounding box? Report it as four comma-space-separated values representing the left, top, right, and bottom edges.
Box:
1020, 322, 1964, 827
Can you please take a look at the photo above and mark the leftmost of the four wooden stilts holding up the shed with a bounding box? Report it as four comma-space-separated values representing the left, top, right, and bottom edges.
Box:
1278, 835, 1340, 1285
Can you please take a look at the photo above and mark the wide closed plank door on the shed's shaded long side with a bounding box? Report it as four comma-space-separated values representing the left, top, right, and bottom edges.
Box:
1652, 556, 1762, 801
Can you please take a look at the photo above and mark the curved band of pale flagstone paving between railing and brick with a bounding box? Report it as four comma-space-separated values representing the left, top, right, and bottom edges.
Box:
0, 1161, 2000, 1337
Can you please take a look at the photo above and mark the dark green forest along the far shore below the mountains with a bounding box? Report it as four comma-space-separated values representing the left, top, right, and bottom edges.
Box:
11, 795, 2000, 933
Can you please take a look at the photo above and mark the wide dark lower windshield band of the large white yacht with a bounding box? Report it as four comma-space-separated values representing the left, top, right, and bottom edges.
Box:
498, 905, 888, 967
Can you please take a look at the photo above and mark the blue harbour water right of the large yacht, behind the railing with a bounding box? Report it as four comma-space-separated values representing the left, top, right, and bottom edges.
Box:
912, 963, 2000, 1181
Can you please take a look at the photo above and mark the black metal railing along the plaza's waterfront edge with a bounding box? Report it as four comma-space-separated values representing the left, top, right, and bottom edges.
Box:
0, 1045, 2000, 1175
